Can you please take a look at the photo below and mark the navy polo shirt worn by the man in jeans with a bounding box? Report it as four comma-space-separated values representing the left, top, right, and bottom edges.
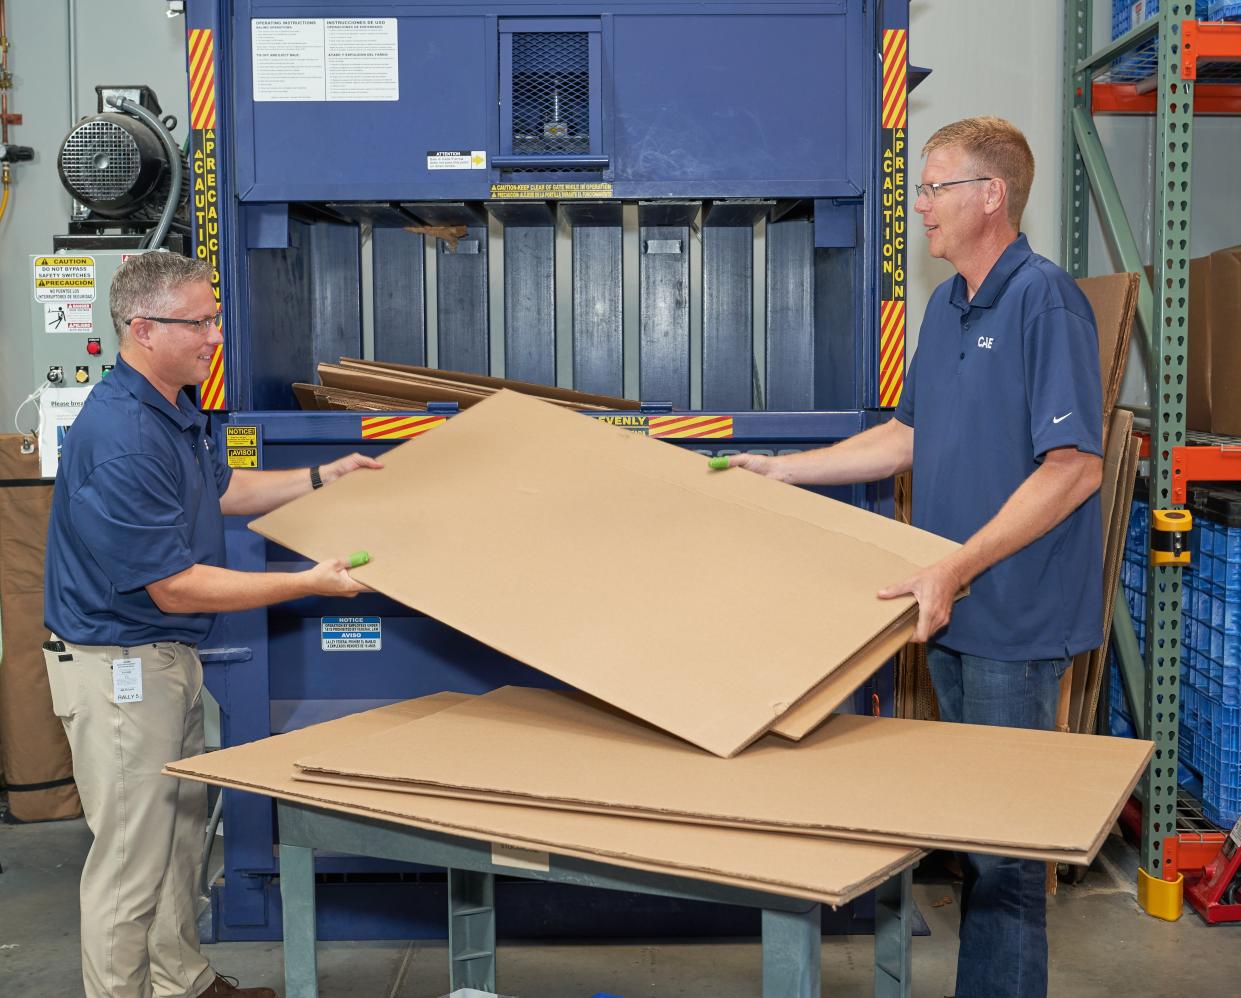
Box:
896, 236, 1103, 660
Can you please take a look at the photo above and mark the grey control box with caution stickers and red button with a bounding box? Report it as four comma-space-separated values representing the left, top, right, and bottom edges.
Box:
30, 250, 140, 389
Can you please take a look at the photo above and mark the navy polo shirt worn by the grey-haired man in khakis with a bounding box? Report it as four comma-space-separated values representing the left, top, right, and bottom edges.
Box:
43, 357, 232, 647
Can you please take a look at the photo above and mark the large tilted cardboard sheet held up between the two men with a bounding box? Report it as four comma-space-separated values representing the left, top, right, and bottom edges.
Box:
251, 392, 957, 756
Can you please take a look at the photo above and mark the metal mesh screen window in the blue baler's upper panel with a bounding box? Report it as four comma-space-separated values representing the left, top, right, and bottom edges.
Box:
513, 31, 591, 155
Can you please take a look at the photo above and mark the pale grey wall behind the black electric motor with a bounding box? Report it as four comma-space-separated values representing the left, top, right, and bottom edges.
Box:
0, 0, 187, 432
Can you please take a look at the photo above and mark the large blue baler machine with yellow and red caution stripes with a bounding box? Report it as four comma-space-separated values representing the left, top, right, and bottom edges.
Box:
187, 0, 923, 940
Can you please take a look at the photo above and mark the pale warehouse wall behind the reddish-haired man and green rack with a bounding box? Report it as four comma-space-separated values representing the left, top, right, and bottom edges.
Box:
908, 0, 1241, 405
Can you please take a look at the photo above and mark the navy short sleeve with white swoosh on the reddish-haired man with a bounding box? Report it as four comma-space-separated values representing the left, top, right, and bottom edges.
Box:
1023, 308, 1103, 459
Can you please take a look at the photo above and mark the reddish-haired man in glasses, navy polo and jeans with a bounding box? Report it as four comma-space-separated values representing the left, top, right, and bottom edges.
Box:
730, 117, 1103, 998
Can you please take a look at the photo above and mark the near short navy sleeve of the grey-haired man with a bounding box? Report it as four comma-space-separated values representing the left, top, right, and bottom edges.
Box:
69, 454, 195, 592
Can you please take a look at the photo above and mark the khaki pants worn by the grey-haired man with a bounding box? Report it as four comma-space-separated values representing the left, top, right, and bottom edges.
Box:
43, 638, 215, 998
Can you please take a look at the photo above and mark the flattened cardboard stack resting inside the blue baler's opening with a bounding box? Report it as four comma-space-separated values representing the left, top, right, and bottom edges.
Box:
301, 357, 639, 412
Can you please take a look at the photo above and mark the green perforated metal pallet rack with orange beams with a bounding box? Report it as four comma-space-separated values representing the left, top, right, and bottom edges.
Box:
1062, 0, 1241, 911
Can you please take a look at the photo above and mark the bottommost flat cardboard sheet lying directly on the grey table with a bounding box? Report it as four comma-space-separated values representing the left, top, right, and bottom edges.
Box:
166, 694, 923, 905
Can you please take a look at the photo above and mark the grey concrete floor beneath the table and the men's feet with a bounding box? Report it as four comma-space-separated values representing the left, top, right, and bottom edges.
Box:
0, 820, 1241, 998
